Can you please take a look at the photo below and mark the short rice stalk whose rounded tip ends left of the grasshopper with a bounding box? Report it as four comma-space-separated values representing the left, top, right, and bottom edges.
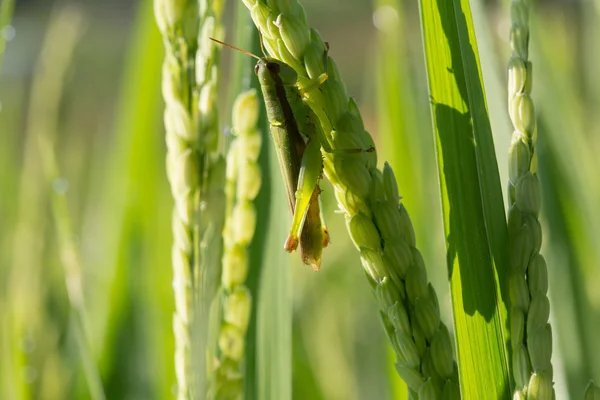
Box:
208, 89, 262, 399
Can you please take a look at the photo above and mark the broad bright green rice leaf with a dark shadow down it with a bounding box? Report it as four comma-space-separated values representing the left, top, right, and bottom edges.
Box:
420, 0, 511, 399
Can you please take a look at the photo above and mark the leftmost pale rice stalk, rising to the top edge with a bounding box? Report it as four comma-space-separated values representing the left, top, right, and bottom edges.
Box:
154, 0, 225, 399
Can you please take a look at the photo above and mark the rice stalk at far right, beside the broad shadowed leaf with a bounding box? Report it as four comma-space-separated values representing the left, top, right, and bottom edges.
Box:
508, 0, 555, 399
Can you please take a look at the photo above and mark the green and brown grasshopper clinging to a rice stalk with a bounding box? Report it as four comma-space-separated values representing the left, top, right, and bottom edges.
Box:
211, 38, 360, 271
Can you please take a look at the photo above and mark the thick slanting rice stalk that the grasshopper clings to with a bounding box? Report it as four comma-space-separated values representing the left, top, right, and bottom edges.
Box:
239, 0, 459, 398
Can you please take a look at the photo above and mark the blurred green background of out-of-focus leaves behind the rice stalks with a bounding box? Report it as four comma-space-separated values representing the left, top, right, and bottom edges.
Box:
0, 0, 600, 399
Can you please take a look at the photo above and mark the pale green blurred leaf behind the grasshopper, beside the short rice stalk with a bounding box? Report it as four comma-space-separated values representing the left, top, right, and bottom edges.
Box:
230, 17, 290, 400
